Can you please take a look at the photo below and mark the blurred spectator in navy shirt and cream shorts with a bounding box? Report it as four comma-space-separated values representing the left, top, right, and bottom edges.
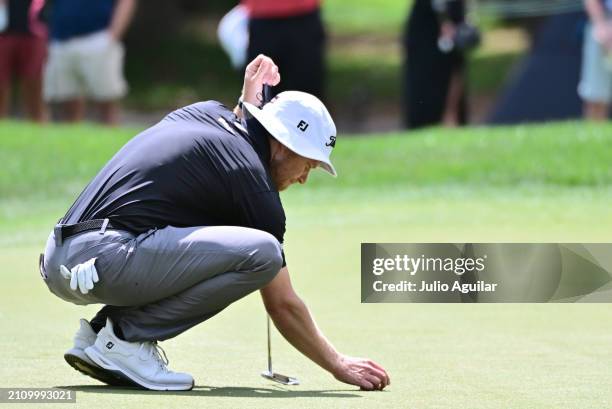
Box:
44, 0, 136, 125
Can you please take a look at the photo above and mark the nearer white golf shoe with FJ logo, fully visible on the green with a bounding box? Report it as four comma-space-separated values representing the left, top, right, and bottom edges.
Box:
85, 319, 194, 391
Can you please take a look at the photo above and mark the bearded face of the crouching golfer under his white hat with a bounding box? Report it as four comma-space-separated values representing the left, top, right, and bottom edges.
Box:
270, 147, 319, 192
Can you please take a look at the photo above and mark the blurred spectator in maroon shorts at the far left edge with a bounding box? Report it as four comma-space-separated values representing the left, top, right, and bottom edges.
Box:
0, 0, 47, 122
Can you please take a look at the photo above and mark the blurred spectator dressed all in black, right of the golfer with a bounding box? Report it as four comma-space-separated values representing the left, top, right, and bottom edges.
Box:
403, 0, 479, 128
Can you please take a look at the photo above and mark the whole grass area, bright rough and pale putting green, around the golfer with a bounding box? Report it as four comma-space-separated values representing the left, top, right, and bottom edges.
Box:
0, 122, 612, 409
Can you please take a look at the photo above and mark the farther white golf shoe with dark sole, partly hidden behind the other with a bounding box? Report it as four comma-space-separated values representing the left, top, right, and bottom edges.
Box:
64, 318, 134, 386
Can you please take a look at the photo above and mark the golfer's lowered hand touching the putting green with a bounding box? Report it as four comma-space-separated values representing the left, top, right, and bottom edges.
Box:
333, 356, 391, 391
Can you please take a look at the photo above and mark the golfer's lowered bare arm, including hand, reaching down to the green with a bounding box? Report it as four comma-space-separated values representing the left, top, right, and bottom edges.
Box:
261, 267, 390, 390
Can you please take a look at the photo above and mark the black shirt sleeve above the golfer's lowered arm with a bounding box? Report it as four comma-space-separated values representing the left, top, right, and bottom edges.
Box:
238, 191, 287, 267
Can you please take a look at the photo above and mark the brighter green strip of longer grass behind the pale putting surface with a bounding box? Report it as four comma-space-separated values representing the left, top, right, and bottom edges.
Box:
5, 122, 612, 199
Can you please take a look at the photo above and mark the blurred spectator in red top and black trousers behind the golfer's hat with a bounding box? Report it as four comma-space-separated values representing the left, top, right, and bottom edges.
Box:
242, 0, 325, 99
